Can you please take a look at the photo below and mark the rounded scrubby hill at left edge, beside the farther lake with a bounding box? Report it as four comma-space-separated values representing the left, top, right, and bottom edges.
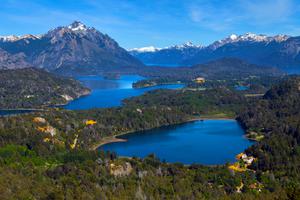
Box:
0, 68, 89, 109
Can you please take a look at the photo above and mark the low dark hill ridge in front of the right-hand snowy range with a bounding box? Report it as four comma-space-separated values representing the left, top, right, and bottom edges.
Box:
141, 58, 284, 81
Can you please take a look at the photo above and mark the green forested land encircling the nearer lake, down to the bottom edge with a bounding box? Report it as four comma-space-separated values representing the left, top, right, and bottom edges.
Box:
0, 77, 300, 199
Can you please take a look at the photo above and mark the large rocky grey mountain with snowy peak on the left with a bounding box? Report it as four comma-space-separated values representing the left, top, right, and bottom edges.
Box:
0, 21, 143, 72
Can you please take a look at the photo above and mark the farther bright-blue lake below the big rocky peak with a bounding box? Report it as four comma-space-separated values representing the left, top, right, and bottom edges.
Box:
64, 75, 184, 110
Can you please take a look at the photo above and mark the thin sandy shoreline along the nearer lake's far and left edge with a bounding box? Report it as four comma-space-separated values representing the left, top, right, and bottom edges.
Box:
91, 116, 235, 150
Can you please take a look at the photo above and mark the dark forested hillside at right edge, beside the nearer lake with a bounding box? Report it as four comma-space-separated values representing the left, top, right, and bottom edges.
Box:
238, 77, 300, 180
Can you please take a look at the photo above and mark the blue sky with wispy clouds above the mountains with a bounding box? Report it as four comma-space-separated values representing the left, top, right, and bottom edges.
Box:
0, 0, 300, 49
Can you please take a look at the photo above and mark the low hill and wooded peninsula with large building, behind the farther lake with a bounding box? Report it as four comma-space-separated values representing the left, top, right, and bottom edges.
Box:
133, 58, 286, 98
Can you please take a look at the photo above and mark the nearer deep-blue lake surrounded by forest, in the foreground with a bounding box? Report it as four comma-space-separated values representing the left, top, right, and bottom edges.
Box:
99, 120, 253, 165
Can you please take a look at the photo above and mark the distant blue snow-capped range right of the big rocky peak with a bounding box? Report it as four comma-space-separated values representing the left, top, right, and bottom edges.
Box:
129, 33, 300, 68
